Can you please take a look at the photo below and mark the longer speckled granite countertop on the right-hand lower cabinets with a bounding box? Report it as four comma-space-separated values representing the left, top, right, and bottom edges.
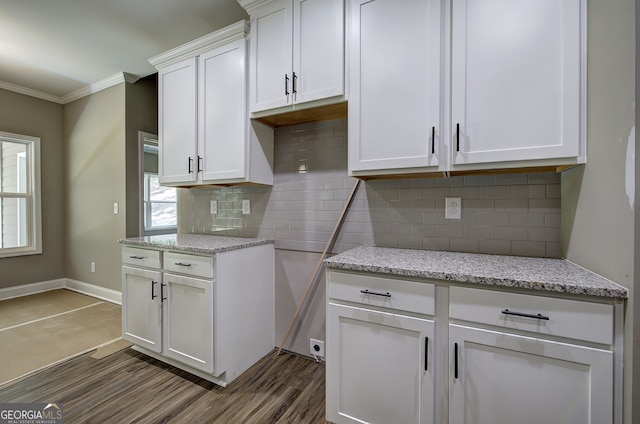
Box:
324, 247, 629, 299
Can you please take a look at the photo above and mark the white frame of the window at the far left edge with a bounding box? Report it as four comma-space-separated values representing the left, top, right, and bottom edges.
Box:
0, 131, 42, 258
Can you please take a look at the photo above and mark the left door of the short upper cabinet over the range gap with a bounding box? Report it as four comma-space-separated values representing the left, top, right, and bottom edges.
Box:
250, 0, 293, 112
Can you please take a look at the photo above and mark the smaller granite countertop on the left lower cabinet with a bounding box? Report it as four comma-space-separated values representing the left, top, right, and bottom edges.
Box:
118, 234, 274, 254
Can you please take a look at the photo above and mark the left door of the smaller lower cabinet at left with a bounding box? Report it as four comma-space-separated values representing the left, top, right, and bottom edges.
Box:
122, 266, 162, 352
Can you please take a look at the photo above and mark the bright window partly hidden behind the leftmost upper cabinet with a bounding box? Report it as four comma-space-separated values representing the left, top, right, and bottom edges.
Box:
144, 173, 178, 233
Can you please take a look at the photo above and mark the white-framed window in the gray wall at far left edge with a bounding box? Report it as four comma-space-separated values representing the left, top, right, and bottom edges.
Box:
0, 132, 42, 257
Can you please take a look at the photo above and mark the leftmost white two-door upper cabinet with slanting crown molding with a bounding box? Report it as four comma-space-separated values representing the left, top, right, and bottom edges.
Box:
149, 22, 273, 186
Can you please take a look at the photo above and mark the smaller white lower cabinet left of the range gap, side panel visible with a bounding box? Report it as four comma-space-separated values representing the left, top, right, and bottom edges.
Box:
122, 244, 275, 386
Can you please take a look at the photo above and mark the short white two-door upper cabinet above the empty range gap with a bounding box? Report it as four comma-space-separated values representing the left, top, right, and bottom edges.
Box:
240, 0, 344, 112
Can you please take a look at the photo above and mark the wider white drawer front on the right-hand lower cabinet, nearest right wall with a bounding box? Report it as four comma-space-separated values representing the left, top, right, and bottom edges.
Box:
449, 287, 613, 345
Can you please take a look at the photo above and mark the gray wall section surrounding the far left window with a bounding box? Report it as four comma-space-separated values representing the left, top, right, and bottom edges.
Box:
0, 89, 65, 288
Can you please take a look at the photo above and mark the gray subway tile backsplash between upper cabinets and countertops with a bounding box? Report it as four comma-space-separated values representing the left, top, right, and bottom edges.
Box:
179, 120, 560, 257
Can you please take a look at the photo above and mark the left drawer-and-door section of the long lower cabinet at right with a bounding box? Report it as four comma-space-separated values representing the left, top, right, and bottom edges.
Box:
326, 272, 435, 424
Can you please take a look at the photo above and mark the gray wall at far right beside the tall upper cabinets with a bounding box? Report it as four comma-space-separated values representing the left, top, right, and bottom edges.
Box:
561, 0, 640, 423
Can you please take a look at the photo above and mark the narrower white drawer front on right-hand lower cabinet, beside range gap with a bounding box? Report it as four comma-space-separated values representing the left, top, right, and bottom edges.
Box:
327, 270, 435, 315
